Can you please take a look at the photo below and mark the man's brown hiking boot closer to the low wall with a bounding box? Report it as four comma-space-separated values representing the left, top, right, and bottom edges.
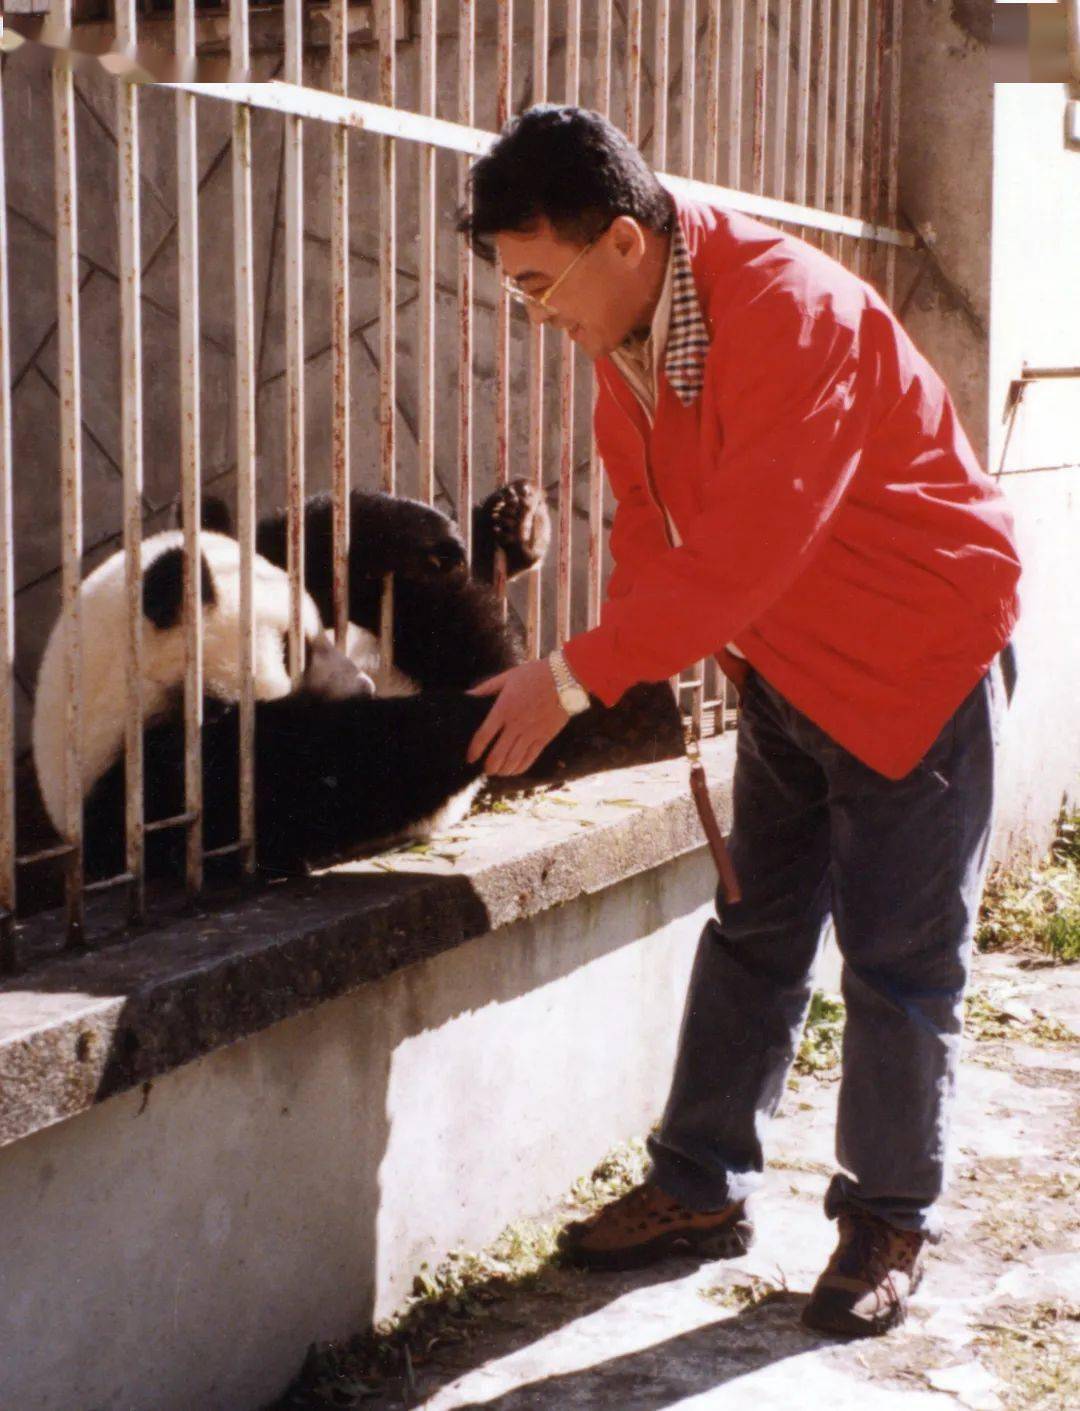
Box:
559, 1181, 754, 1268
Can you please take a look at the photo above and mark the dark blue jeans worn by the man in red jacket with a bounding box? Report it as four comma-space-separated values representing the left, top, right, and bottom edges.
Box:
649, 648, 1014, 1239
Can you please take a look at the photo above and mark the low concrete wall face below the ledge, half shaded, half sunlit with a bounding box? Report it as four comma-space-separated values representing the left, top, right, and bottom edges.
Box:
0, 851, 714, 1411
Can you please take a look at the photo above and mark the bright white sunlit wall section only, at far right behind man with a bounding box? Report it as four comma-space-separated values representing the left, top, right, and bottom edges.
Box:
988, 83, 1080, 856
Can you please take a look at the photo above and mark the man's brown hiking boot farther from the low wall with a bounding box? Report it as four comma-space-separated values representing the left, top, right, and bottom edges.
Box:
802, 1206, 926, 1338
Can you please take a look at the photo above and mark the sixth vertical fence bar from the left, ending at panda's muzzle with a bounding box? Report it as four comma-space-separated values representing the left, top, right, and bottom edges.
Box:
284, 0, 305, 689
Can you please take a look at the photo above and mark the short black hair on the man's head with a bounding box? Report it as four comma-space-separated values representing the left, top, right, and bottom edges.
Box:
457, 103, 672, 261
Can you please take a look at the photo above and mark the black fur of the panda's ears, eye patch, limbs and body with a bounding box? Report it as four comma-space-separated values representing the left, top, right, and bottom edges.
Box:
61, 481, 679, 876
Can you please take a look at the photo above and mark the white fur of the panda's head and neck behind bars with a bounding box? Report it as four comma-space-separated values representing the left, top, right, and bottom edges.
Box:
32, 529, 324, 832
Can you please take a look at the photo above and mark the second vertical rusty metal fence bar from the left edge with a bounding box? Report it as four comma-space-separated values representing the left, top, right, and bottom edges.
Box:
49, 0, 86, 945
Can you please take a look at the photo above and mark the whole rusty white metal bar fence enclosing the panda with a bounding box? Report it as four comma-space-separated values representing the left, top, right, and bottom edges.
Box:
0, 0, 912, 969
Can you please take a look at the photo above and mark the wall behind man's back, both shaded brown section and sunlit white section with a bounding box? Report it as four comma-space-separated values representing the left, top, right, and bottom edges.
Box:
898, 0, 1080, 861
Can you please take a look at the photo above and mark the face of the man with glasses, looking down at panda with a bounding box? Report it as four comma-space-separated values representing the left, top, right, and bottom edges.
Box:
496, 216, 647, 358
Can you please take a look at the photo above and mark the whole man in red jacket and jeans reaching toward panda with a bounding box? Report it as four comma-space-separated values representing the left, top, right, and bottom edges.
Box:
460, 106, 1019, 1335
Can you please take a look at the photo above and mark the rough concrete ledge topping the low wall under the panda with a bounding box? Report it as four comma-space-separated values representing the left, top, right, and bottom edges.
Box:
0, 737, 734, 1146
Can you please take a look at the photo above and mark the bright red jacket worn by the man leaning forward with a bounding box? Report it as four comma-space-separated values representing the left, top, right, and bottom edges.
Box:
565, 193, 1019, 779
